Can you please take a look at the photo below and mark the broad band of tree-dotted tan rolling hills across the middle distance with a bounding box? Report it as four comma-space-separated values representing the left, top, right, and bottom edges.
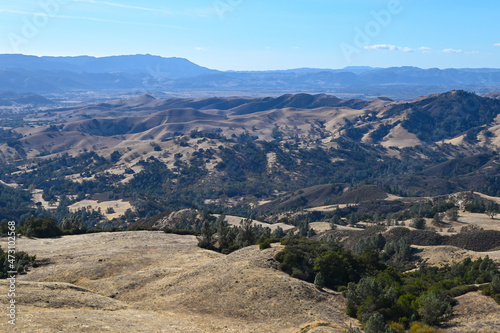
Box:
0, 91, 500, 223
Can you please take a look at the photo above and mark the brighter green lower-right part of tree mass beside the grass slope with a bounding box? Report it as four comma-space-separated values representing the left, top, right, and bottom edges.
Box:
345, 257, 500, 327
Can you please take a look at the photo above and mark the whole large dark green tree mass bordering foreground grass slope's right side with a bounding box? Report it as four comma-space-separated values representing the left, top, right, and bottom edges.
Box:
276, 234, 500, 332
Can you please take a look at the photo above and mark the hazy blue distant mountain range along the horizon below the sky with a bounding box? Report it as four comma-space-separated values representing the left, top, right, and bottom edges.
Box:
0, 54, 500, 99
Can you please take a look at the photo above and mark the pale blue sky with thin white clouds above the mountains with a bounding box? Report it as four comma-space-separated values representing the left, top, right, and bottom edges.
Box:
0, 0, 500, 70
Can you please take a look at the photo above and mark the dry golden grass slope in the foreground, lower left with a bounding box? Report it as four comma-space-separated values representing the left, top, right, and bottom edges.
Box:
0, 231, 357, 333
